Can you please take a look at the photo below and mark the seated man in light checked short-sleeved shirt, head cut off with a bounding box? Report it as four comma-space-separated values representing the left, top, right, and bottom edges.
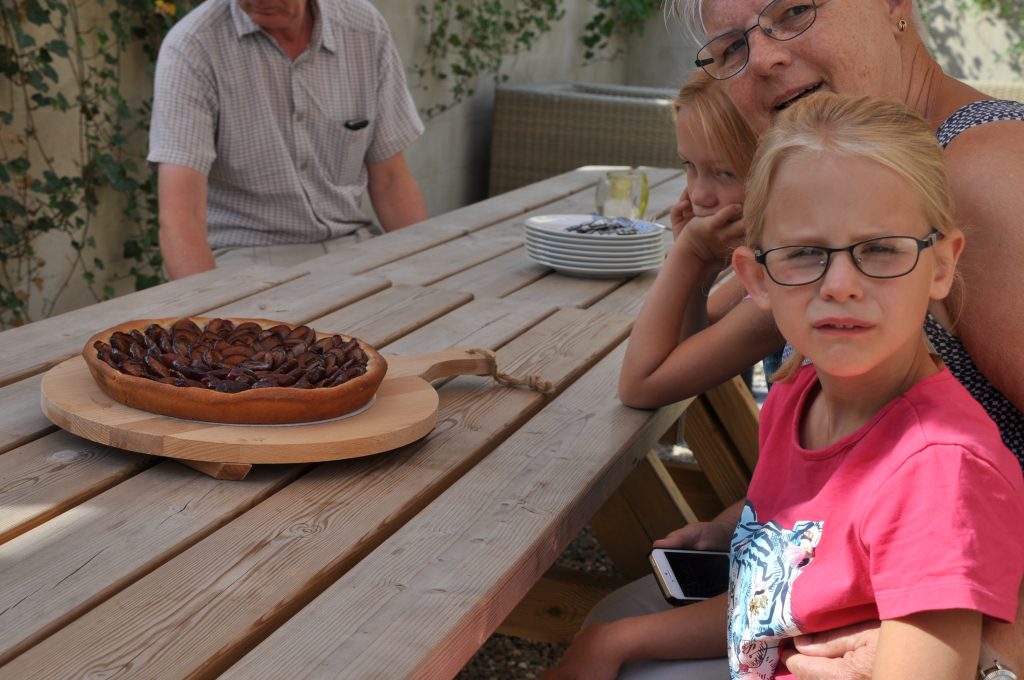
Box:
147, 0, 427, 279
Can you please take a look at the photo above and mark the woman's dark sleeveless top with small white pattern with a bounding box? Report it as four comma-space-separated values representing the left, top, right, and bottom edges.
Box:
925, 99, 1024, 468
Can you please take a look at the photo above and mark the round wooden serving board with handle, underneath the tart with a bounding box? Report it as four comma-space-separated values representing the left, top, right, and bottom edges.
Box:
42, 348, 495, 476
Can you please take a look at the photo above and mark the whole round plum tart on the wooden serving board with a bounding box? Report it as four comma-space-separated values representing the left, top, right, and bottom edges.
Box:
82, 316, 387, 424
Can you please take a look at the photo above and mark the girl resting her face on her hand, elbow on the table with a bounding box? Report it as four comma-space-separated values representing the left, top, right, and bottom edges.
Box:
618, 71, 782, 409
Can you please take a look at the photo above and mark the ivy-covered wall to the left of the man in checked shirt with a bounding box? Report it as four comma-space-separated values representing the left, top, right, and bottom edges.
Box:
0, 0, 198, 328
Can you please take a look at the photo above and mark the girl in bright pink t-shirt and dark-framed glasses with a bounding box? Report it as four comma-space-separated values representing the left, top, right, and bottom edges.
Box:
546, 94, 1024, 680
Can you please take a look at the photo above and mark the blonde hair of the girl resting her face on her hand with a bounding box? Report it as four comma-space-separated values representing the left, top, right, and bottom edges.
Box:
675, 71, 758, 177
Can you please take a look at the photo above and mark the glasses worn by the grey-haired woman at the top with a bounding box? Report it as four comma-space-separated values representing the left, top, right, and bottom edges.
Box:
694, 0, 818, 80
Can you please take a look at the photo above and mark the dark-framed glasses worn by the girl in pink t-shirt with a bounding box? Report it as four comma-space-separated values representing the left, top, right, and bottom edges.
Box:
754, 231, 942, 286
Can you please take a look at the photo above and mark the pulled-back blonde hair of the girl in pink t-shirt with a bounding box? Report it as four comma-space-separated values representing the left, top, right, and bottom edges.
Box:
743, 92, 954, 381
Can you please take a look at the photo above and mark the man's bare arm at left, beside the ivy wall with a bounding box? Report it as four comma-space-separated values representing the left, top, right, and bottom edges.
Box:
157, 163, 215, 279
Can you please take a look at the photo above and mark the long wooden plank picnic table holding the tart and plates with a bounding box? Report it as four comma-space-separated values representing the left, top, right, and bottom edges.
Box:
0, 169, 729, 680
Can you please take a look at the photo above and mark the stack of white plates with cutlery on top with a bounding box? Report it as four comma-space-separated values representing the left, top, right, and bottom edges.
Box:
525, 215, 665, 279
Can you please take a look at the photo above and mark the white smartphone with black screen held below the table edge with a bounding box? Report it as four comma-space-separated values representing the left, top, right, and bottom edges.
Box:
649, 548, 729, 605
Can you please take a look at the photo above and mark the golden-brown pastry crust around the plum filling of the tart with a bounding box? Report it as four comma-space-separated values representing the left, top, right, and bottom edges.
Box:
82, 316, 387, 425
